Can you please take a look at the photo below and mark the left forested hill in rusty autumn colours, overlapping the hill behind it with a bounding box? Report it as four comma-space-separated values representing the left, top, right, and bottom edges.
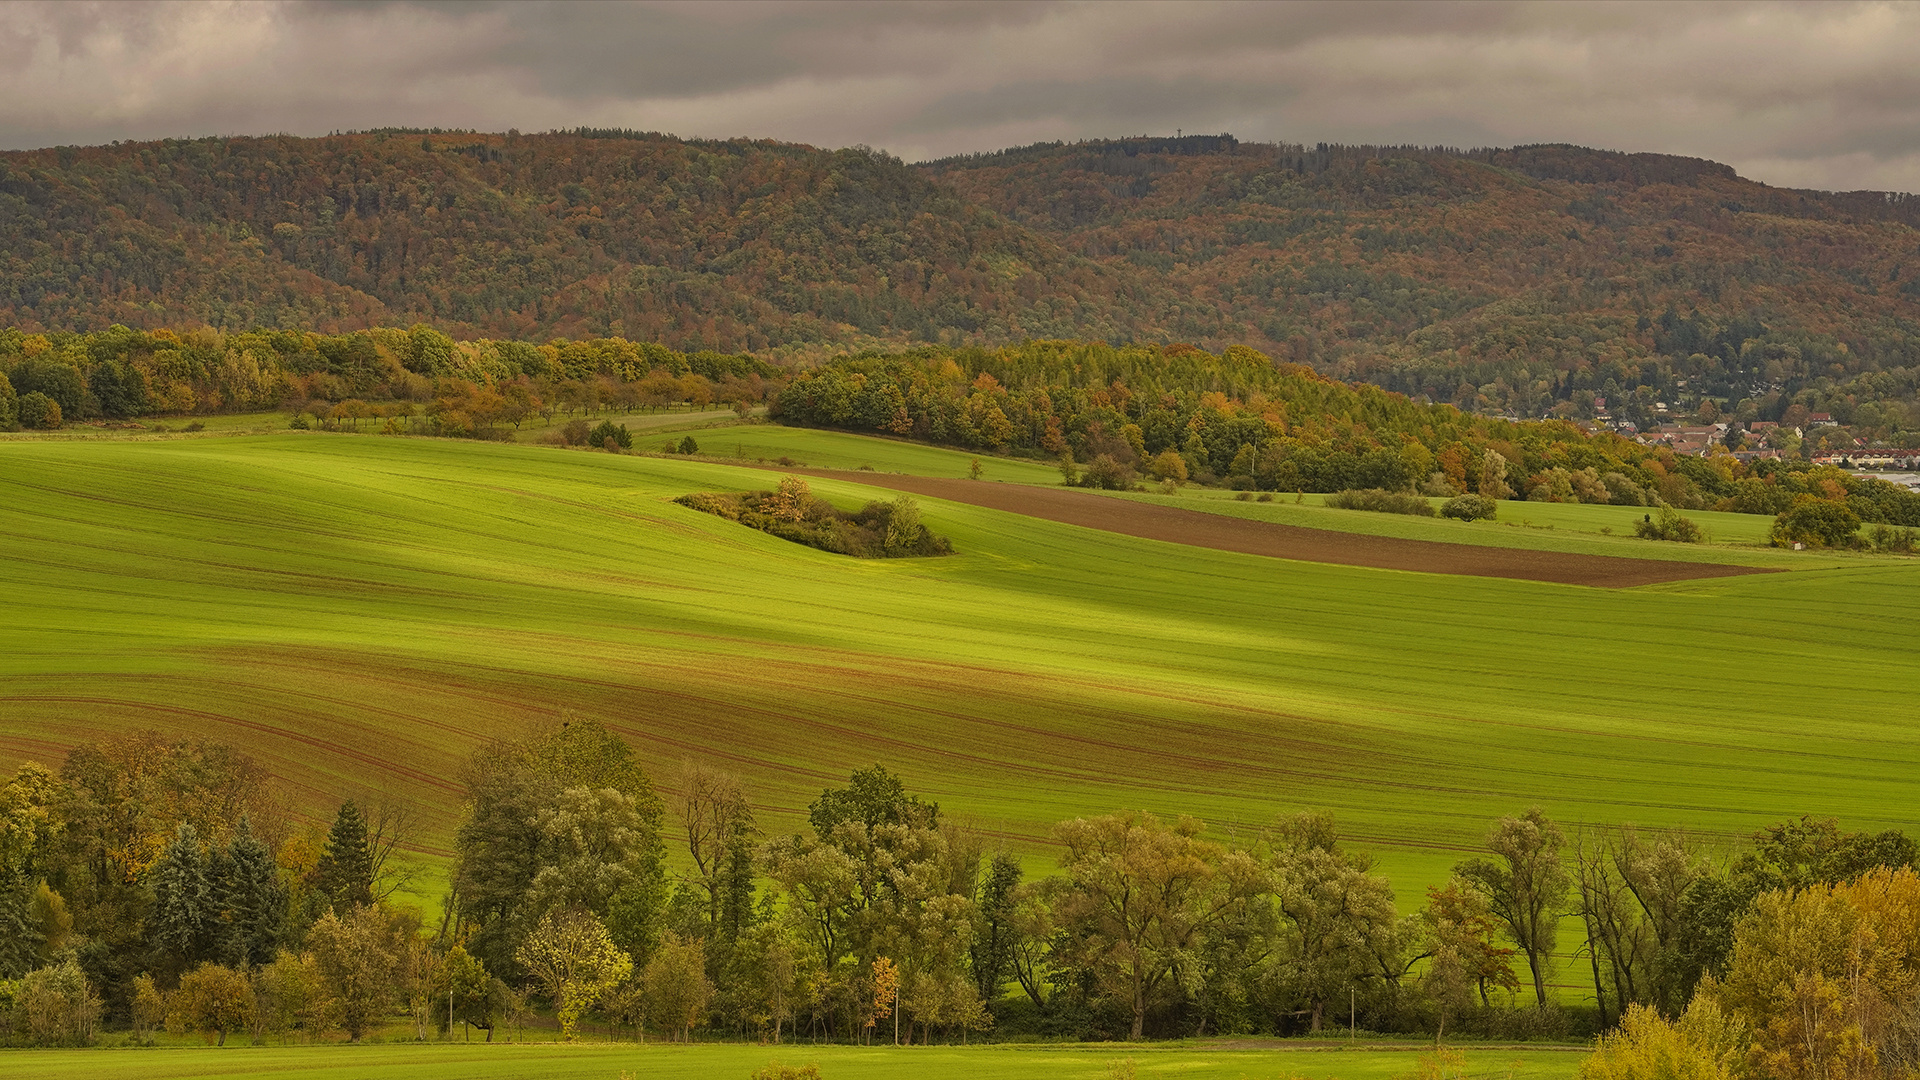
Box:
0, 133, 1164, 352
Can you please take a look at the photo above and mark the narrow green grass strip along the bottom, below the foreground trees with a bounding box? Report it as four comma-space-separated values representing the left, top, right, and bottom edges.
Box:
0, 1043, 1580, 1080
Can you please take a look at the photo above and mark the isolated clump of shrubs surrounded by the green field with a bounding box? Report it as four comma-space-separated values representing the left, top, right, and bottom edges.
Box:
674, 477, 954, 559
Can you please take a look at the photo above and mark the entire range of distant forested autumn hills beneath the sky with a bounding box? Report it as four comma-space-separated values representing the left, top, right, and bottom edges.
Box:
11, 131, 1920, 422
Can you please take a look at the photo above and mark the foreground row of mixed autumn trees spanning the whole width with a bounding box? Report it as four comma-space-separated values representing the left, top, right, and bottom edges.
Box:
0, 717, 1920, 1060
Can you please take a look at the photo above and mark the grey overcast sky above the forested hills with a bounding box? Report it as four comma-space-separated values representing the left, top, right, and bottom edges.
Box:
0, 0, 1920, 192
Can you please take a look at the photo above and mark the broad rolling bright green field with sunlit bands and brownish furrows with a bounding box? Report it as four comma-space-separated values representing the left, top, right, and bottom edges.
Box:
0, 425, 1920, 986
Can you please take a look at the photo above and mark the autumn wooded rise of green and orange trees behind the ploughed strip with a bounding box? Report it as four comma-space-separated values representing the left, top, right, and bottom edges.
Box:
774, 342, 1920, 527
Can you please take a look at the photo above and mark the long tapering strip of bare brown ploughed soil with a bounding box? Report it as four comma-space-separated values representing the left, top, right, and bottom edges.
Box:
748, 469, 1780, 588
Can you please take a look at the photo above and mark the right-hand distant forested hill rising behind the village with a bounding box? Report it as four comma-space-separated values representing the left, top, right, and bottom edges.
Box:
924, 136, 1920, 423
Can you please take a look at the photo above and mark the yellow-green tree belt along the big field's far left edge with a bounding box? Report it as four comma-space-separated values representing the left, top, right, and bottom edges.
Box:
0, 325, 780, 436
